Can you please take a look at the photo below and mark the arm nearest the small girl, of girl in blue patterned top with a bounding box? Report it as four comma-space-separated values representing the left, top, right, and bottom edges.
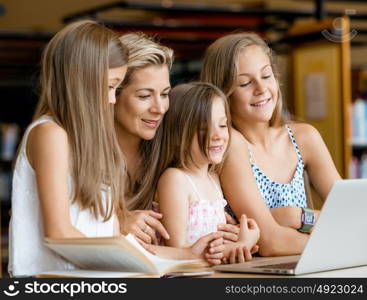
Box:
220, 130, 309, 256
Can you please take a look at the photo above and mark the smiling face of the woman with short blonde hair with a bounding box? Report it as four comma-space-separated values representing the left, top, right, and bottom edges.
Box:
115, 65, 171, 140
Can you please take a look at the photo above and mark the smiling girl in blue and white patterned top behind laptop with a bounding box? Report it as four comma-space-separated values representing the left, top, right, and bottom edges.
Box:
201, 33, 340, 256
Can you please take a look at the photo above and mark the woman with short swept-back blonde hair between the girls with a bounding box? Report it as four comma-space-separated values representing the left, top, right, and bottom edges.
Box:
115, 33, 230, 264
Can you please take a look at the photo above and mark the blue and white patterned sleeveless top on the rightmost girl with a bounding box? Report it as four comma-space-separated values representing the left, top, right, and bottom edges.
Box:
249, 125, 307, 209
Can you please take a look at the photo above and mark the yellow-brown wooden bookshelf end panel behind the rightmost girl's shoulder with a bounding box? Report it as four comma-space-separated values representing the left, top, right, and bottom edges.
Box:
291, 17, 352, 208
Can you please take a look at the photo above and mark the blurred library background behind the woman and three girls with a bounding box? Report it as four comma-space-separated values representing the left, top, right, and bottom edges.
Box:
0, 0, 367, 277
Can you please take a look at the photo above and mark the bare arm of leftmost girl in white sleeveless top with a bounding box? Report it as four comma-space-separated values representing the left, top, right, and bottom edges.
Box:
26, 122, 84, 238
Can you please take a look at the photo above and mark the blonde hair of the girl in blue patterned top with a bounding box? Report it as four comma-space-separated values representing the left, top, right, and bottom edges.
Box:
200, 32, 284, 127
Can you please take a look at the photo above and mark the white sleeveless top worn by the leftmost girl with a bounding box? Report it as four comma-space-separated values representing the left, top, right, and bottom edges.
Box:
8, 116, 115, 276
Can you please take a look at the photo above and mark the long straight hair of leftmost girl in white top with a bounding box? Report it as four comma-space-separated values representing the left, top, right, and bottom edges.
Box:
34, 21, 128, 221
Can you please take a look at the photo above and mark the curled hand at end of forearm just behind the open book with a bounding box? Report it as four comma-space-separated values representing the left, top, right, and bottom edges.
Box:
190, 232, 224, 265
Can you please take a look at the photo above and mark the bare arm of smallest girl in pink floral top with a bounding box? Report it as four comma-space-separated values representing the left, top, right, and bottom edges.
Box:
157, 168, 190, 248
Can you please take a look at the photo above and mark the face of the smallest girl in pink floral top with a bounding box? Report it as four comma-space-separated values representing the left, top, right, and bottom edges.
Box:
191, 96, 229, 165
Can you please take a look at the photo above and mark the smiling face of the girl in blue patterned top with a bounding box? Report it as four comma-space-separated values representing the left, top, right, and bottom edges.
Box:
230, 45, 278, 122
